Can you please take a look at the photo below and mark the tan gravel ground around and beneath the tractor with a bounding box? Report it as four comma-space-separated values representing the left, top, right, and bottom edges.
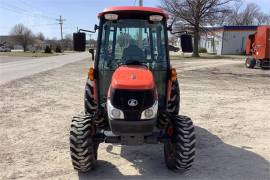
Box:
0, 59, 270, 180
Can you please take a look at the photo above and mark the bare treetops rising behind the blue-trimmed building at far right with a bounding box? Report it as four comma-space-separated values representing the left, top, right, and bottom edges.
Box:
226, 2, 270, 25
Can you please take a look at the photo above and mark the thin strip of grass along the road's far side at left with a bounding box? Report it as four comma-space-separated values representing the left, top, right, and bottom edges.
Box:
0, 52, 58, 57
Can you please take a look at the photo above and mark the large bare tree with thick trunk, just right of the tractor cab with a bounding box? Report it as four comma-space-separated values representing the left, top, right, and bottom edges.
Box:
161, 0, 235, 57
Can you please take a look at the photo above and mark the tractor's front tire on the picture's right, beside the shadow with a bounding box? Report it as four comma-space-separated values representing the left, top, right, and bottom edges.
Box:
164, 115, 196, 172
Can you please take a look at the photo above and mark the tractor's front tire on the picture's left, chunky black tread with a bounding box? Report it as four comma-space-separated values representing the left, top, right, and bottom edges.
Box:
70, 115, 98, 172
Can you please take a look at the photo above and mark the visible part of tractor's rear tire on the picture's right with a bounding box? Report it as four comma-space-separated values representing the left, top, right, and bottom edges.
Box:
167, 79, 180, 115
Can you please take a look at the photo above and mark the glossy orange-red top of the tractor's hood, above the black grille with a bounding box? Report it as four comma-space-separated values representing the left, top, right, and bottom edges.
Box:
111, 65, 155, 90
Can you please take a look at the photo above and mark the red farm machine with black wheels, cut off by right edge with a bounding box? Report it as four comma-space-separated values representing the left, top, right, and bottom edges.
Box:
245, 26, 270, 69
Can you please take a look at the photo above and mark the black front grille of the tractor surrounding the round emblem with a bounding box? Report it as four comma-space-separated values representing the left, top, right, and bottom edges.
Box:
111, 89, 155, 110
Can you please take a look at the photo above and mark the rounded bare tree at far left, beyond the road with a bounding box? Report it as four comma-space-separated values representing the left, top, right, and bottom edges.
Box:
10, 24, 34, 52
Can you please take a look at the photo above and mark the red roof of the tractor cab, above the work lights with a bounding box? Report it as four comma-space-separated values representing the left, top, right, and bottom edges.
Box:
98, 6, 168, 19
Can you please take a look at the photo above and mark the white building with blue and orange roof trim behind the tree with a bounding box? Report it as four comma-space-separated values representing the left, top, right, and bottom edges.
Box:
199, 26, 257, 55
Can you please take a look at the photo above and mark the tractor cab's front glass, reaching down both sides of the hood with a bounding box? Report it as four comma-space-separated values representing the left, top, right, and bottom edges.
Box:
97, 19, 168, 105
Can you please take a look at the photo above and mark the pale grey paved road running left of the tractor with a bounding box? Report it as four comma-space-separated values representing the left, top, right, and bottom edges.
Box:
0, 52, 90, 84
